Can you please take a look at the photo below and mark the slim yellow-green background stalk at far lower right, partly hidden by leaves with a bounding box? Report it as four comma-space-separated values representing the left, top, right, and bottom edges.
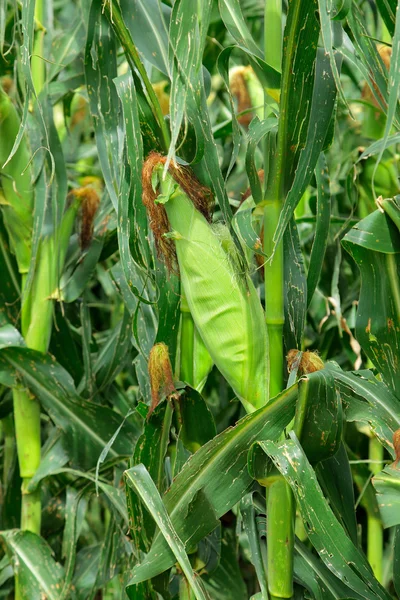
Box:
367, 437, 383, 583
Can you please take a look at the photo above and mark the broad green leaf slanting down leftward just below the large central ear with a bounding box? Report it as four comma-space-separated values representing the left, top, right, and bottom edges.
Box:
127, 386, 297, 584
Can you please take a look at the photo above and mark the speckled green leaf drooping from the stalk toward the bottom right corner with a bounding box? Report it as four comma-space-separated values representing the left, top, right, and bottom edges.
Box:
260, 432, 390, 600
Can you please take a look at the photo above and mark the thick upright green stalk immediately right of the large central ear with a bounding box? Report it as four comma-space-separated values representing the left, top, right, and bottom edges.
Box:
264, 0, 296, 600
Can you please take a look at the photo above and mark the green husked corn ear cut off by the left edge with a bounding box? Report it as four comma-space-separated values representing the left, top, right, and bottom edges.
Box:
0, 89, 33, 273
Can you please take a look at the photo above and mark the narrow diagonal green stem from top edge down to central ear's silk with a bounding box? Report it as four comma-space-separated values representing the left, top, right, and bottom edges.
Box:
103, 0, 171, 152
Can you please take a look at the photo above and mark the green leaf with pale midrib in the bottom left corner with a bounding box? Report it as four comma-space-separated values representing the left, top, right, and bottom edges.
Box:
1, 529, 67, 600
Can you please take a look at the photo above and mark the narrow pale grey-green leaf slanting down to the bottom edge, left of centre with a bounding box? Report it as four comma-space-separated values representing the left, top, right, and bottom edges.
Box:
125, 465, 208, 600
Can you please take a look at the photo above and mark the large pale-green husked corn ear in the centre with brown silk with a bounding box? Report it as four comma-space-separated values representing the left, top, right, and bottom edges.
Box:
153, 165, 268, 411
